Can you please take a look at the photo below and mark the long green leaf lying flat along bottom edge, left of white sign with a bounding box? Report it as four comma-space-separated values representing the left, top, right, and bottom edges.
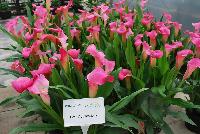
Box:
9, 123, 62, 134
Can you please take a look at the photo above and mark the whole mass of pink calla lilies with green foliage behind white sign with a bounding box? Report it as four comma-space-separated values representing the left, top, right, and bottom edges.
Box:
0, 0, 200, 134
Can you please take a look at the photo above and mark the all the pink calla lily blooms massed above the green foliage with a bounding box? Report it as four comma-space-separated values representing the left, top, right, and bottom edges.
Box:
6, 0, 200, 104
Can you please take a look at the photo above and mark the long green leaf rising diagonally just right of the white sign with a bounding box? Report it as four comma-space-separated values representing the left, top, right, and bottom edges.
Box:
109, 88, 148, 112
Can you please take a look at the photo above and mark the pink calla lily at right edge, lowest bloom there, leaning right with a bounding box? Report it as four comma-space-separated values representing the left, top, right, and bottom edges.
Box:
183, 58, 200, 80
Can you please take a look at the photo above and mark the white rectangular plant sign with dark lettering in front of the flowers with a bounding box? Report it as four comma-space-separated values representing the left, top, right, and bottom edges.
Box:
63, 97, 105, 127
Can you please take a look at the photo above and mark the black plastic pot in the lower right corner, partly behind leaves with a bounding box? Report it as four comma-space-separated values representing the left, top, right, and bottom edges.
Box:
185, 109, 200, 134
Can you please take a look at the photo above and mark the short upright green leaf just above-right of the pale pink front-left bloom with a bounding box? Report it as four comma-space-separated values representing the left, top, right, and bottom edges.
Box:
51, 69, 64, 85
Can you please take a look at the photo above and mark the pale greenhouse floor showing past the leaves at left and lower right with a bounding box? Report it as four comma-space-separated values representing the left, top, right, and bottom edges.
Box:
0, 20, 193, 134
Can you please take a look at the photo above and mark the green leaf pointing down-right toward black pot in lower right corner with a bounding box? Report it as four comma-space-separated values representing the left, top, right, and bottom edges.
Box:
169, 111, 196, 125
